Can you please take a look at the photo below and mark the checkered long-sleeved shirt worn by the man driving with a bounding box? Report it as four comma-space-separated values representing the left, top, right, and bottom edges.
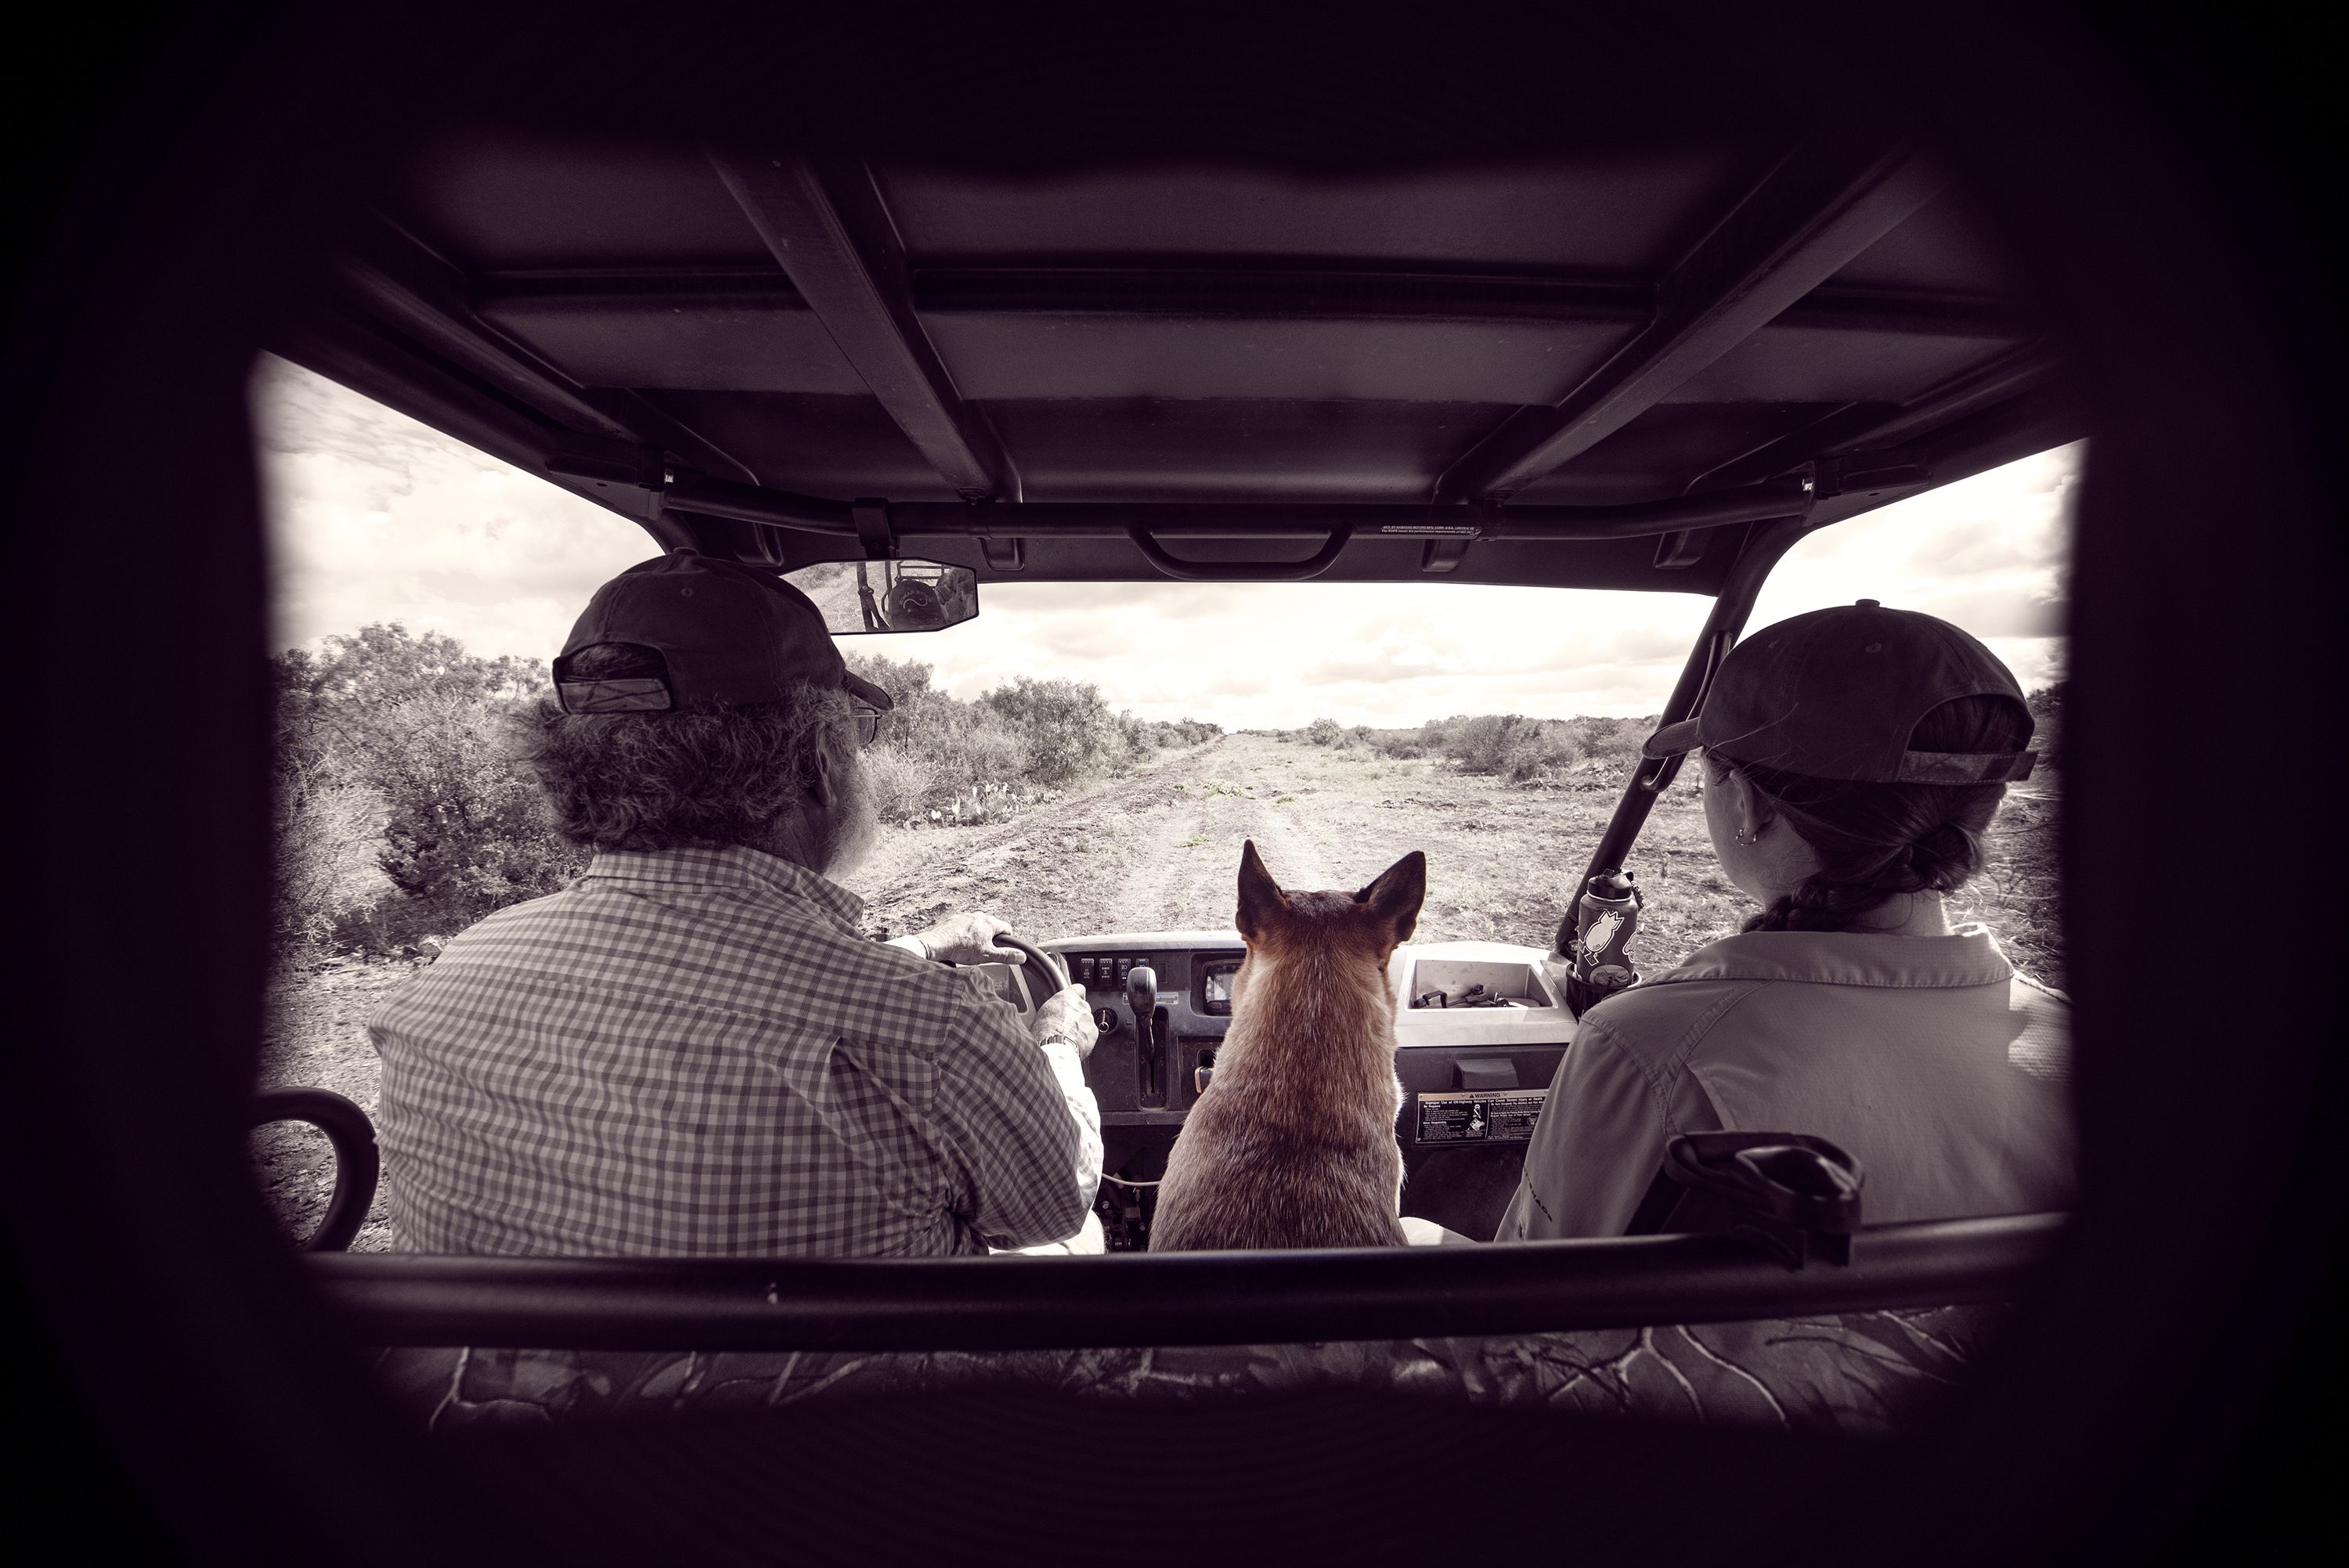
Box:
366, 847, 1102, 1256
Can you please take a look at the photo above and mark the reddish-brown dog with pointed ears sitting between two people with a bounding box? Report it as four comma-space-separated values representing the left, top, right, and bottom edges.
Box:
1151, 842, 1428, 1251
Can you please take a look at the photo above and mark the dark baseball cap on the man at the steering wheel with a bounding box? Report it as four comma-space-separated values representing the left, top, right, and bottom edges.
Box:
554, 550, 890, 714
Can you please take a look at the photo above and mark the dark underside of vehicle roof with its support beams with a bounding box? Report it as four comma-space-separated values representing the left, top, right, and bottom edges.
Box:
277, 127, 2079, 592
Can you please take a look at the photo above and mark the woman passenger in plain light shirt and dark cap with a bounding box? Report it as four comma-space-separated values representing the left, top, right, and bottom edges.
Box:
1496, 599, 2072, 1242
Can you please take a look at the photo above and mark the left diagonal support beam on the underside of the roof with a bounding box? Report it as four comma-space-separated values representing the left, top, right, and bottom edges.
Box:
709, 153, 1019, 500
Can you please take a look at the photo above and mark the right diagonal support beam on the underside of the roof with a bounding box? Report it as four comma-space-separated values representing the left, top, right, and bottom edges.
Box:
1435, 143, 1940, 503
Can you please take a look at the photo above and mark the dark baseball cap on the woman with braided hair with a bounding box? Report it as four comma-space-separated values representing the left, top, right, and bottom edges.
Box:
1640, 599, 2039, 784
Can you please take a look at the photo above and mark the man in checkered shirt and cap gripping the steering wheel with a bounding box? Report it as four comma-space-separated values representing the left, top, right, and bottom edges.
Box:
369, 552, 1102, 1256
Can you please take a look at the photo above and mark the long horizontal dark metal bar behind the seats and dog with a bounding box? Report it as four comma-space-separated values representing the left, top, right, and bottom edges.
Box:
303, 1213, 2065, 1350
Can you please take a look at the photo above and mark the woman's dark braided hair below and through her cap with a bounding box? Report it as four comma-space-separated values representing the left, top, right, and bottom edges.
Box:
1705, 697, 2032, 932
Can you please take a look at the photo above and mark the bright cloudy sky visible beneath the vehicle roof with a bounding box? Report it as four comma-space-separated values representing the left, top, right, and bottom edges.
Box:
254, 359, 2081, 730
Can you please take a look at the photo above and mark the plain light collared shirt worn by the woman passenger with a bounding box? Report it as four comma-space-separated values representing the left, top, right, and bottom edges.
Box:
1494, 925, 2072, 1242
